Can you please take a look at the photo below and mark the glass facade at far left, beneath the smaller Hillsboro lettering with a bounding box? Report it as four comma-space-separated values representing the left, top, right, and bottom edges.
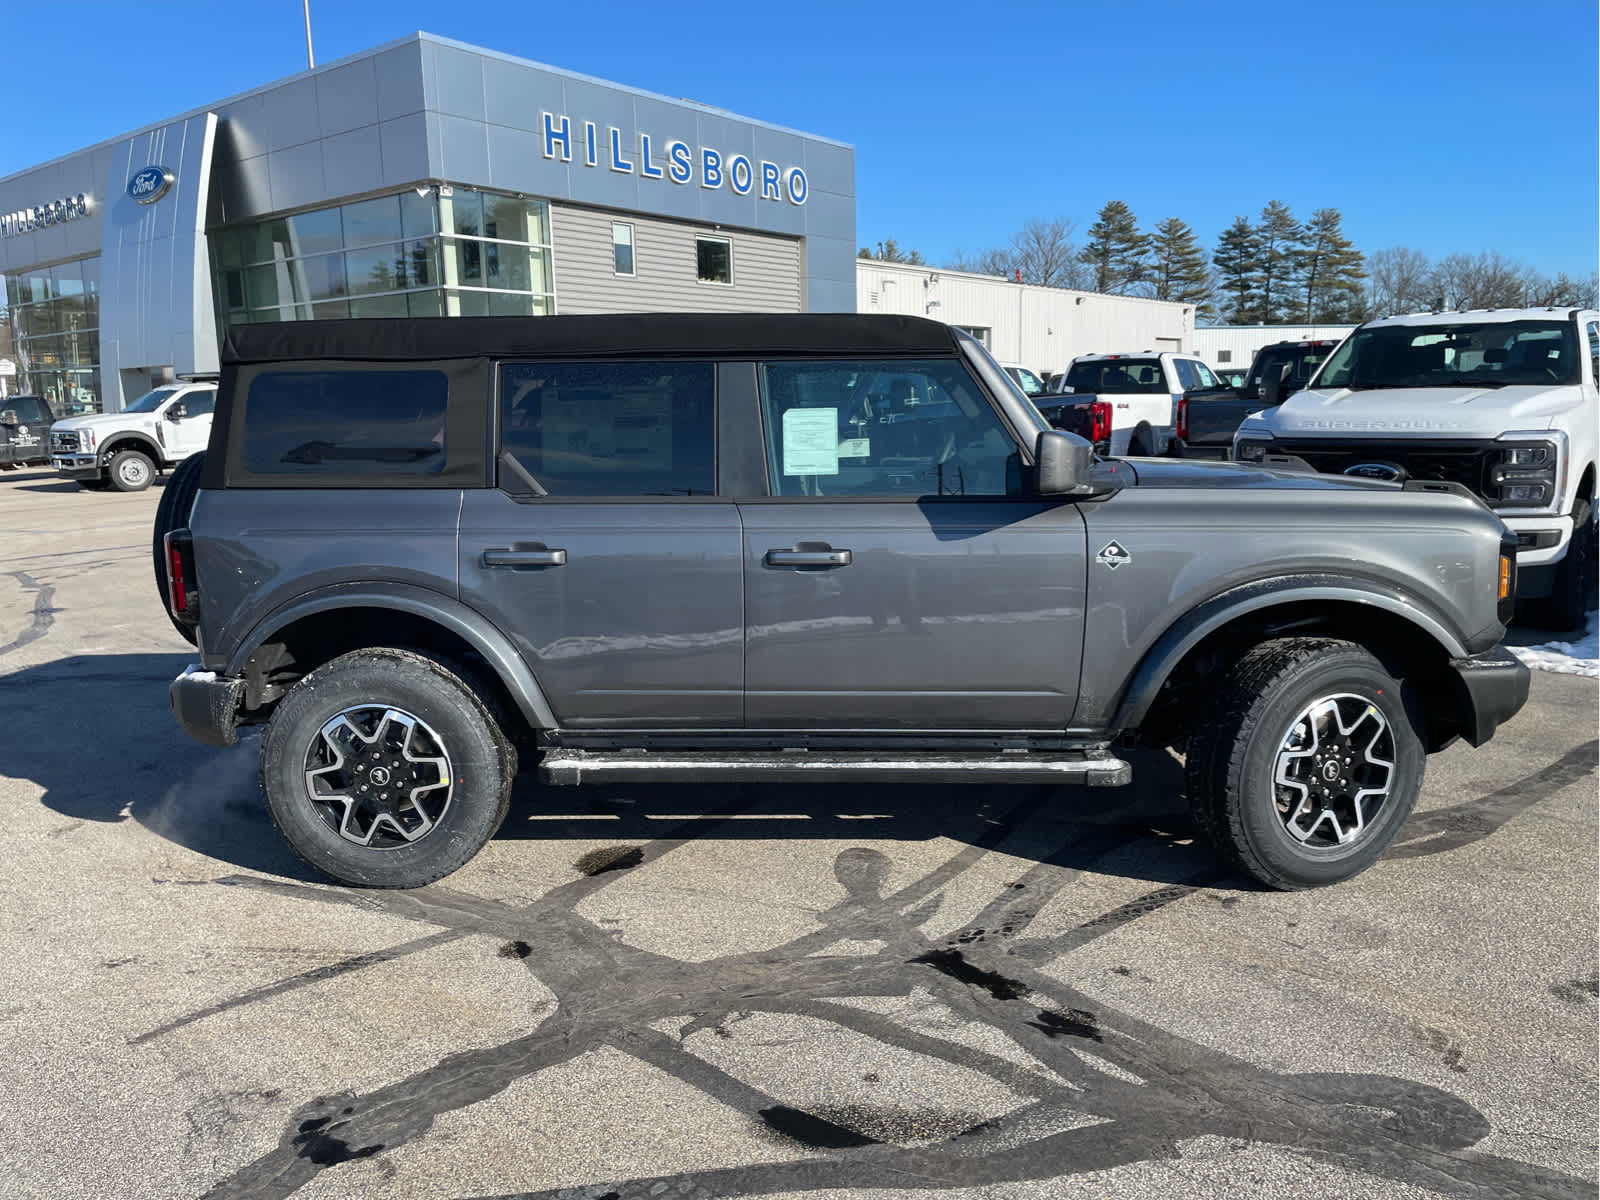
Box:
5, 258, 101, 416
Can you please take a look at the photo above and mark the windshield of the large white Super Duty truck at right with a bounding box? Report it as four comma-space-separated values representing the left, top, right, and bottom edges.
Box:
1312, 320, 1578, 389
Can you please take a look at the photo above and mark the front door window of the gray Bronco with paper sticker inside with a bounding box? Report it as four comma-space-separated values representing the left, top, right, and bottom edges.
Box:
762, 360, 1021, 498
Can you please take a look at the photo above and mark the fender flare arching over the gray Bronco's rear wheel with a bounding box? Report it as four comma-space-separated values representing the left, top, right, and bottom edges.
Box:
226, 582, 555, 730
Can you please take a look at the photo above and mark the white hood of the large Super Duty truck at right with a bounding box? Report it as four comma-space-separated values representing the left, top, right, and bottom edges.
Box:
1256, 384, 1582, 438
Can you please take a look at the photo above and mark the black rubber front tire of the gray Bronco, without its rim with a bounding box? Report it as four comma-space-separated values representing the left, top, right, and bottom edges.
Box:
1184, 637, 1426, 891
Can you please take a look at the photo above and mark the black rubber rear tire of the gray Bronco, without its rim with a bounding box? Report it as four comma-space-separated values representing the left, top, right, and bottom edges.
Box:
261, 646, 517, 888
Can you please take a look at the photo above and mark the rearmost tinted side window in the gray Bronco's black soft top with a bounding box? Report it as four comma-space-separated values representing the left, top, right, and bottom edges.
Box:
243, 371, 450, 477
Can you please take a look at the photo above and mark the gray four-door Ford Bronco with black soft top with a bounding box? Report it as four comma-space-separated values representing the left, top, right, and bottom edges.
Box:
154, 314, 1528, 888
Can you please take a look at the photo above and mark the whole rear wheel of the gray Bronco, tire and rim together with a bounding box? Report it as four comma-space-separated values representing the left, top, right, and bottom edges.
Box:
261, 648, 517, 888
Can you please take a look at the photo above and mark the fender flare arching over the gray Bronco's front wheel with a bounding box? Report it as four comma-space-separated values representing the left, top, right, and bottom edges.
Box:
1110, 574, 1470, 733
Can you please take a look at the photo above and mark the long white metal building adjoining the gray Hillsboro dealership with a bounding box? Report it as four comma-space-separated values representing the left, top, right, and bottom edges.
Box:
856, 258, 1195, 374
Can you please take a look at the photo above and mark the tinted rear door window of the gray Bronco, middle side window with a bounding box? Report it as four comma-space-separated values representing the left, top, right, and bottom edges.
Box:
499, 363, 717, 496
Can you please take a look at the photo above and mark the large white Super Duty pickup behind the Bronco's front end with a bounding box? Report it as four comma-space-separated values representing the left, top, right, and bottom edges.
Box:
1234, 309, 1600, 630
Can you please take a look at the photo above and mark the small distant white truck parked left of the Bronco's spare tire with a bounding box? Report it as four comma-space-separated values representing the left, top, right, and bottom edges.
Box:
50, 382, 216, 491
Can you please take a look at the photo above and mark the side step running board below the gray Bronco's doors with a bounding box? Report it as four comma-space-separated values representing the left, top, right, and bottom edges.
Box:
539, 749, 1133, 787
